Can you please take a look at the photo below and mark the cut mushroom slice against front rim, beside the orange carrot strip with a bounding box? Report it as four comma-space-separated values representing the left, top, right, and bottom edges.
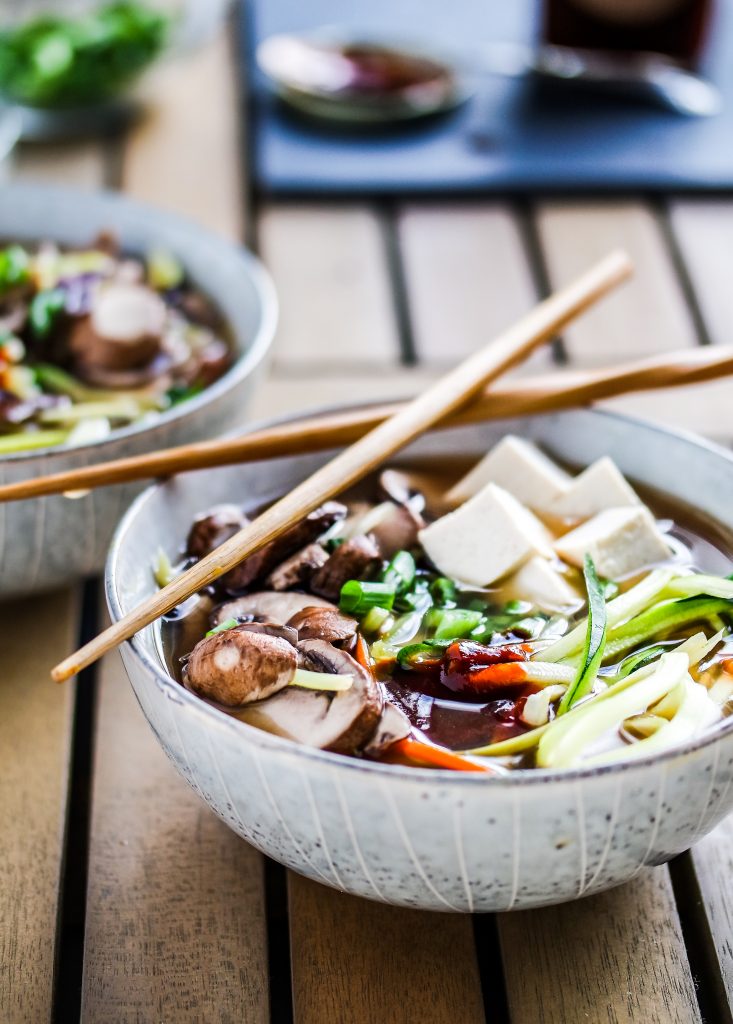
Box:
238, 640, 384, 754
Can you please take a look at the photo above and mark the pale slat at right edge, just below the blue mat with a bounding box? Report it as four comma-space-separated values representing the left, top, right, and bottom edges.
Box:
670, 199, 733, 344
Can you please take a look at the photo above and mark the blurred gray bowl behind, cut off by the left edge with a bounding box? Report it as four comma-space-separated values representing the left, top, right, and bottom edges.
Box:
0, 185, 277, 598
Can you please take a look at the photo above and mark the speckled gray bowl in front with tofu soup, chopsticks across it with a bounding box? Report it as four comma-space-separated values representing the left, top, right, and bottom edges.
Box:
106, 412, 733, 911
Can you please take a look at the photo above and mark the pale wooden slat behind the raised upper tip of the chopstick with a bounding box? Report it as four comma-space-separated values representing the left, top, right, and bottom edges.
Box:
537, 201, 697, 366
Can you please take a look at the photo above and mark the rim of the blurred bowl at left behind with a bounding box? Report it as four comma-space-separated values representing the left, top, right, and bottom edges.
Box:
0, 182, 279, 466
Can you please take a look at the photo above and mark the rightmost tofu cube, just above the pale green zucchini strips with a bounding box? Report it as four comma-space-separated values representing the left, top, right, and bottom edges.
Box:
555, 505, 670, 580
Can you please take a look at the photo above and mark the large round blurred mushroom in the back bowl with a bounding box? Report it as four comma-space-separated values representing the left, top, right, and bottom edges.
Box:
70, 282, 167, 371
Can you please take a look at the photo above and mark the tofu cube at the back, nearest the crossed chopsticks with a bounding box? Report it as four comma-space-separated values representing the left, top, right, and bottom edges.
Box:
446, 434, 572, 512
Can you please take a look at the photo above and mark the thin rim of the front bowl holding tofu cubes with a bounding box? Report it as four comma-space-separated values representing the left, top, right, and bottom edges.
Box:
104, 402, 733, 788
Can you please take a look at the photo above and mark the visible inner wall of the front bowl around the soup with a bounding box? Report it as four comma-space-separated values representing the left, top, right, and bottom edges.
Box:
106, 410, 733, 784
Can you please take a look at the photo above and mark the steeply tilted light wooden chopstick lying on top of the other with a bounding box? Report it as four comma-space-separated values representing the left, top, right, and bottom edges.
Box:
51, 251, 632, 682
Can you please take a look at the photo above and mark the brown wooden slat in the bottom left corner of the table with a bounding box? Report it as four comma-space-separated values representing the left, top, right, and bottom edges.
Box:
0, 591, 78, 1024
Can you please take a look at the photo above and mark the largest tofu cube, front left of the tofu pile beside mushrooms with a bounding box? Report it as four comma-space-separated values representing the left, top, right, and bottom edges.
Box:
419, 483, 552, 587
